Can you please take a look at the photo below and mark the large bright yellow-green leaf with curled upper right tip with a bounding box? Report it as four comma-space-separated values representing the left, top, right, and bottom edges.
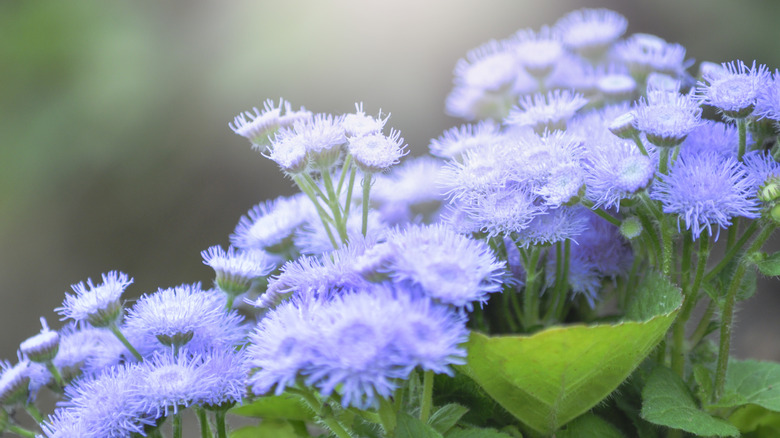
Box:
460, 274, 682, 435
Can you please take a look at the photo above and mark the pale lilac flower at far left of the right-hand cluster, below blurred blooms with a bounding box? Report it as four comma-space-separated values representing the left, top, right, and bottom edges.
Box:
428, 120, 501, 160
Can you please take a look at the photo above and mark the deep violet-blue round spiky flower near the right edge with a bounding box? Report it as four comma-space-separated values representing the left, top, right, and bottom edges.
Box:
650, 153, 758, 239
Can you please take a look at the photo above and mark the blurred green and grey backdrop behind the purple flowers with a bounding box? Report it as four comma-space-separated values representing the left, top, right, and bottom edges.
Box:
0, 0, 780, 360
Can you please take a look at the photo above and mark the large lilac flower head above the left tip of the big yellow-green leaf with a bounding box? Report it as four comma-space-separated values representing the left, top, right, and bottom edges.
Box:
386, 225, 506, 309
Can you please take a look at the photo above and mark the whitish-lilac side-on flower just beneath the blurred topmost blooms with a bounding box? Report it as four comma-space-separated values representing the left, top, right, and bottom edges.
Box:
504, 90, 588, 133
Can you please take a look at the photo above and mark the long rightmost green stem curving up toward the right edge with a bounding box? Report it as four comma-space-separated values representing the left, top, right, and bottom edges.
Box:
712, 225, 774, 401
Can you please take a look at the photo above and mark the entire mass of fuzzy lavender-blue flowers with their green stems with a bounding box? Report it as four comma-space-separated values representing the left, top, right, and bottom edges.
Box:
0, 9, 780, 438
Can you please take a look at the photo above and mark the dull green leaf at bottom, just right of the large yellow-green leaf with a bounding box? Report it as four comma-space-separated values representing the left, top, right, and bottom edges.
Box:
641, 367, 739, 436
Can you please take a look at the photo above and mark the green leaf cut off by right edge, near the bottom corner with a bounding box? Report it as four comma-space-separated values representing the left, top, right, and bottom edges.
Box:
711, 359, 780, 412
